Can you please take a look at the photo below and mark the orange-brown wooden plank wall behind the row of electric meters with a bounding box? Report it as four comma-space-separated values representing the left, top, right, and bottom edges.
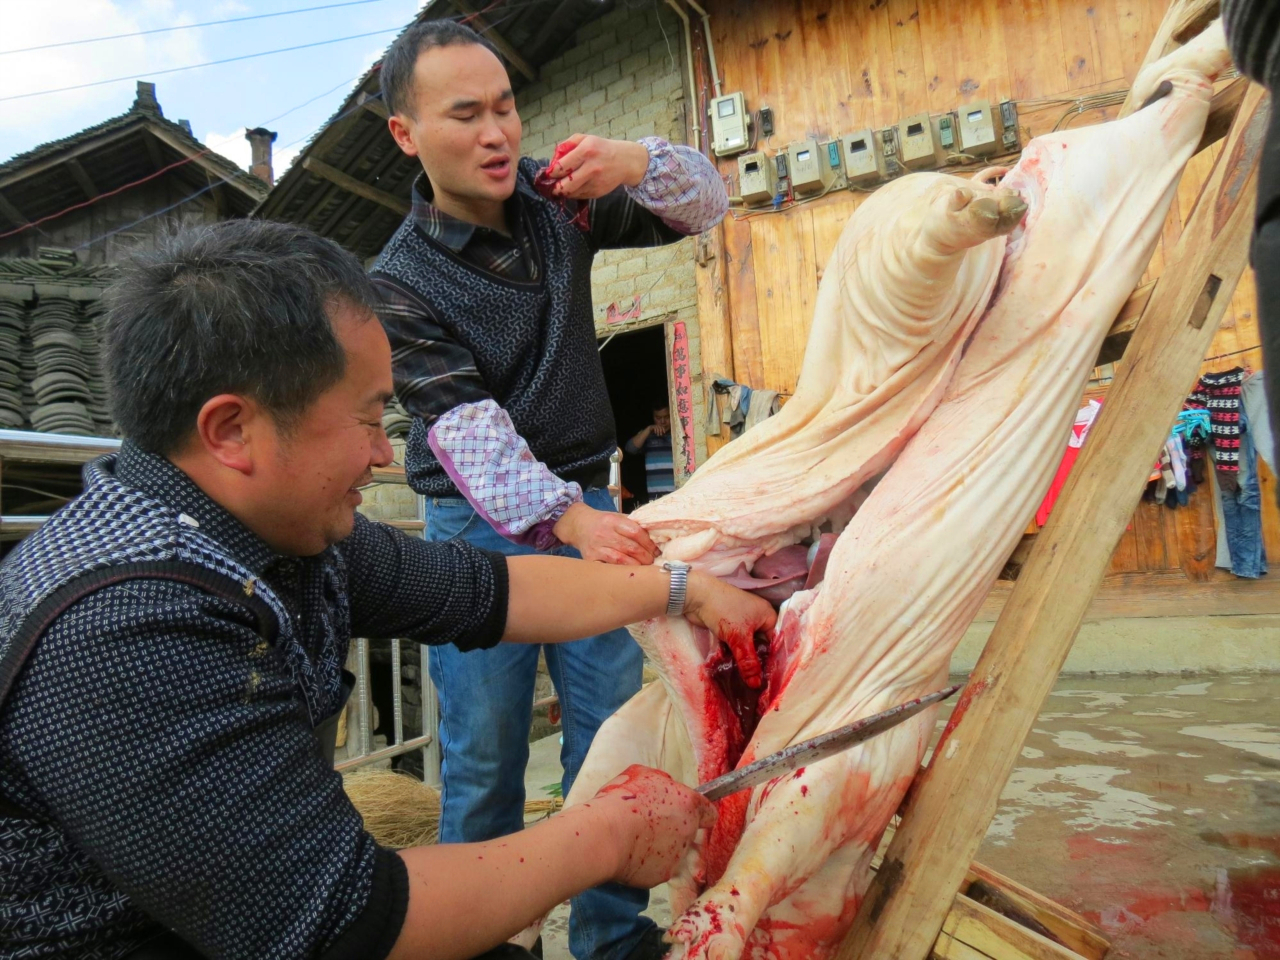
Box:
704, 0, 1280, 580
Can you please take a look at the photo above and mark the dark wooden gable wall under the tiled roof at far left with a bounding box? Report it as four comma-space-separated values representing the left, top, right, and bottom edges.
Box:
0, 177, 227, 265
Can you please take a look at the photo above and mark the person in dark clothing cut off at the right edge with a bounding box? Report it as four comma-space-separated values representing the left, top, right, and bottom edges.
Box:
1222, 0, 1280, 502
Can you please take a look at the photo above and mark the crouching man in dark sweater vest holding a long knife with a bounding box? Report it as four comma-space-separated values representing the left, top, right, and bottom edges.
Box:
0, 220, 774, 960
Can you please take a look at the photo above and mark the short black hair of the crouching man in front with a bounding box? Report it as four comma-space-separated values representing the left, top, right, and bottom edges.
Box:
102, 220, 378, 454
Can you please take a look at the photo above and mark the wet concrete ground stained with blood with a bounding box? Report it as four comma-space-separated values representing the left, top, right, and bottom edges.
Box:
527, 676, 1280, 960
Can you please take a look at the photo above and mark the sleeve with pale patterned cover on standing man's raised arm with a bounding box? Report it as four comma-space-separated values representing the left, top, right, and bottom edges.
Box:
588, 137, 728, 250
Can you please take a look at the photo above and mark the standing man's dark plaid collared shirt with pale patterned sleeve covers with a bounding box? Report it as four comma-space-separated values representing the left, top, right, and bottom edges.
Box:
375, 137, 728, 549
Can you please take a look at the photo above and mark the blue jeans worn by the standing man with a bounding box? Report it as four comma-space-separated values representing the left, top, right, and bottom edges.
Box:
426, 488, 654, 960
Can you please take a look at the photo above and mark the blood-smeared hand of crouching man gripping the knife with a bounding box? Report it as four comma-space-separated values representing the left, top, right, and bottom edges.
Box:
591, 764, 716, 888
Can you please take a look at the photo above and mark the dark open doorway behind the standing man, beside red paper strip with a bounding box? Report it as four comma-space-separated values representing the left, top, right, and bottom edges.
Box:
600, 324, 667, 513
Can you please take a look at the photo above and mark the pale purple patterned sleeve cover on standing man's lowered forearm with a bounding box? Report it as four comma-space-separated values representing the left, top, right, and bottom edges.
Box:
426, 399, 582, 550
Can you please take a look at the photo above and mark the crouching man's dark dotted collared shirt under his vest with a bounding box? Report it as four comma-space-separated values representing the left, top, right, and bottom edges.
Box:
0, 442, 507, 960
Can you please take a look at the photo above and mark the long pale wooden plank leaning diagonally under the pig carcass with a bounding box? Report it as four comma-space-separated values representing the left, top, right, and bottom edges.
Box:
837, 65, 1267, 960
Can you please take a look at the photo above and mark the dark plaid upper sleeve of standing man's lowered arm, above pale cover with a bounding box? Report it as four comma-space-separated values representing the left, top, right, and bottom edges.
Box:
374, 276, 490, 426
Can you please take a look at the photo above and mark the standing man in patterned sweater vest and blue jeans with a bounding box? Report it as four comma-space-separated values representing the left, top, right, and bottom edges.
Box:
371, 20, 728, 960
